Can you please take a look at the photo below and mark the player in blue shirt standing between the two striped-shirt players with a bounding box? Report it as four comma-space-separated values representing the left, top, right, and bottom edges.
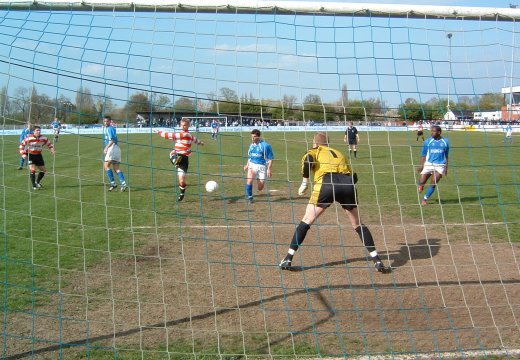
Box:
103, 116, 128, 192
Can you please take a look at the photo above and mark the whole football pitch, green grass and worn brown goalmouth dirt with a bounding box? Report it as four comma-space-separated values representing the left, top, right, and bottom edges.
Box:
0, 129, 520, 359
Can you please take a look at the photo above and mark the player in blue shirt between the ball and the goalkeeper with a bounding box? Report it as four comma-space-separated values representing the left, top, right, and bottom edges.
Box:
244, 129, 274, 201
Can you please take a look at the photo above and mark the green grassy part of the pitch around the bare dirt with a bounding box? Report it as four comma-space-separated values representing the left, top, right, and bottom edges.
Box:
0, 131, 520, 358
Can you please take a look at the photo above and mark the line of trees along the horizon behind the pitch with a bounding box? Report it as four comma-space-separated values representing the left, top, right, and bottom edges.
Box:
0, 85, 503, 124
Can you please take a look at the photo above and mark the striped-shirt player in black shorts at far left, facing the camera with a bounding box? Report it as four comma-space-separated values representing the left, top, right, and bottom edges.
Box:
20, 126, 55, 190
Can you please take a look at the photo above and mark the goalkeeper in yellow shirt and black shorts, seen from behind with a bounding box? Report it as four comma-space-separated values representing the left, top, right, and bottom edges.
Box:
279, 132, 390, 273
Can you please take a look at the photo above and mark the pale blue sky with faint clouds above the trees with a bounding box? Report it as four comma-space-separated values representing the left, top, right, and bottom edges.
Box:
0, 0, 520, 112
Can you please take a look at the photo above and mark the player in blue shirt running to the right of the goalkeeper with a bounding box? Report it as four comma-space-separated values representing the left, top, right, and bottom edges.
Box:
417, 125, 450, 205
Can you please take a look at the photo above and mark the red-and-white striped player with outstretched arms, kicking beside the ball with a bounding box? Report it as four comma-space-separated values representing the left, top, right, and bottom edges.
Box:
157, 119, 204, 201
